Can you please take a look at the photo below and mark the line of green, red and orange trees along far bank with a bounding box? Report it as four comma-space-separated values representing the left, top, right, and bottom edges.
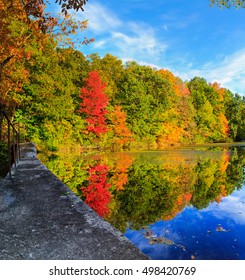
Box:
11, 50, 245, 151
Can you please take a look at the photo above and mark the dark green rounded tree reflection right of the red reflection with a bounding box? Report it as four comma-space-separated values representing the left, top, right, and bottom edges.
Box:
112, 158, 178, 230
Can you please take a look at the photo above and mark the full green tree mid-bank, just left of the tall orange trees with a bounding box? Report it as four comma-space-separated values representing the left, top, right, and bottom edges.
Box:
116, 62, 171, 148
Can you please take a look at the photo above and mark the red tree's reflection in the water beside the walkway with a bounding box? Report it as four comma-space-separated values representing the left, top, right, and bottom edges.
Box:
81, 164, 111, 217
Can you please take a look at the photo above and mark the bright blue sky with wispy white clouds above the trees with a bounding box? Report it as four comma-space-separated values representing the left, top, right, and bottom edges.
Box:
51, 0, 245, 95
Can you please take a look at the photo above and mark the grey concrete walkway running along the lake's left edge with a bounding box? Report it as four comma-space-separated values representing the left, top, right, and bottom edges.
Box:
0, 143, 148, 260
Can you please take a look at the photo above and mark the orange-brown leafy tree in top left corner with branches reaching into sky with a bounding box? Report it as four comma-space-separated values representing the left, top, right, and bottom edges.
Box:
0, 0, 91, 107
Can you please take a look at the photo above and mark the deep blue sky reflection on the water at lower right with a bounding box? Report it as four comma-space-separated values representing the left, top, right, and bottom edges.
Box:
125, 178, 245, 260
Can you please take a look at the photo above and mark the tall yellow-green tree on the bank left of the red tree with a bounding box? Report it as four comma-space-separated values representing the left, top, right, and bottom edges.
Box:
15, 38, 85, 151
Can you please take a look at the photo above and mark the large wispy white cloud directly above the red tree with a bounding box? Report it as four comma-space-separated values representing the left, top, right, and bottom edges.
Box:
78, 3, 167, 64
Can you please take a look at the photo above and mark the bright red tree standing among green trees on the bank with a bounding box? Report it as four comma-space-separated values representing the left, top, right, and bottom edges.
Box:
79, 71, 109, 135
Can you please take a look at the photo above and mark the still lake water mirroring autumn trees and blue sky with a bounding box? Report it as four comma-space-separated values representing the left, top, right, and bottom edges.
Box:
42, 145, 245, 260
